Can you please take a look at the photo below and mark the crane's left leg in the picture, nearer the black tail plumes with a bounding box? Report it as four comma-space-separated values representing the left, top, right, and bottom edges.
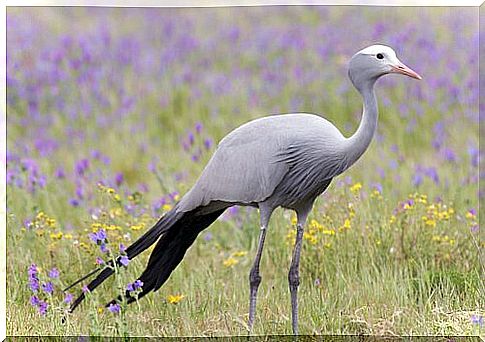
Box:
248, 206, 272, 331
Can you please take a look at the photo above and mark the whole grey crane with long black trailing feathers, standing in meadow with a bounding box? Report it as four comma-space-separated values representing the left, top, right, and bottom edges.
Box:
65, 44, 422, 335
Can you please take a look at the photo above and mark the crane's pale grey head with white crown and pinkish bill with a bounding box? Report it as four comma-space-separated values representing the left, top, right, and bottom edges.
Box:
349, 45, 421, 89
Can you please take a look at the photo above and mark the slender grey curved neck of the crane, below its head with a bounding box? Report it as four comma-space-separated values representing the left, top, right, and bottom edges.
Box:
345, 80, 378, 166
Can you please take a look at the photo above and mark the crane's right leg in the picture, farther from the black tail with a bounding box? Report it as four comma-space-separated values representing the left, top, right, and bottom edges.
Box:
288, 211, 308, 335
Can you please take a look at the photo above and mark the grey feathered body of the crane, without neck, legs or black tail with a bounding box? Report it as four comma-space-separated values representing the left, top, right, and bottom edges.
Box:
179, 113, 348, 211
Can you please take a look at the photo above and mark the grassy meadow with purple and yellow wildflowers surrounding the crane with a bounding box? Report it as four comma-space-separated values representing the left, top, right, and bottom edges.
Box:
6, 6, 485, 336
